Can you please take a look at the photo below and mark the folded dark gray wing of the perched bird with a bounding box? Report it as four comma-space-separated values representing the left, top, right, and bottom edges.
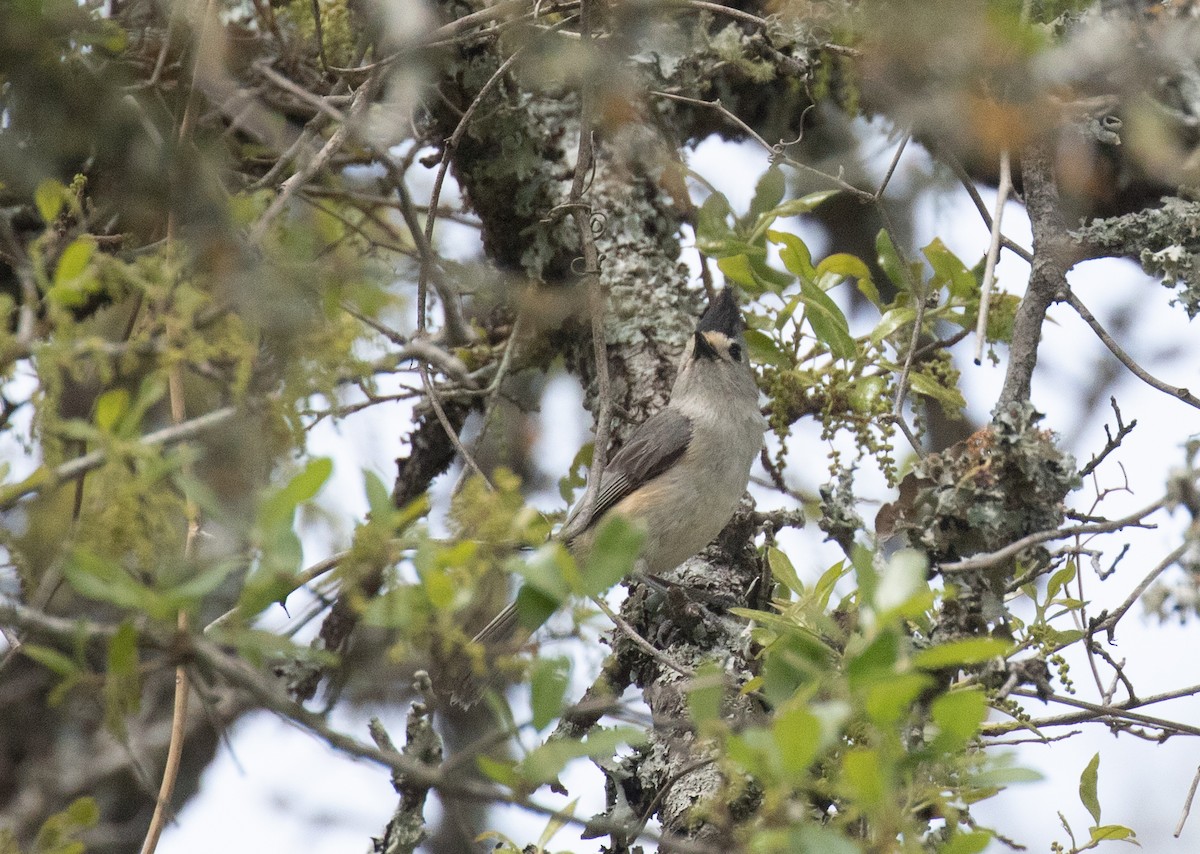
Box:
562, 407, 691, 543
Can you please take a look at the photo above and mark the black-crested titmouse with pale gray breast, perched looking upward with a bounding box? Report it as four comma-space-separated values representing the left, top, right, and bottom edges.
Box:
475, 288, 767, 643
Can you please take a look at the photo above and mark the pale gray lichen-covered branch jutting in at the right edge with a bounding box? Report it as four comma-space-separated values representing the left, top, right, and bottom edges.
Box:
1070, 197, 1200, 318
